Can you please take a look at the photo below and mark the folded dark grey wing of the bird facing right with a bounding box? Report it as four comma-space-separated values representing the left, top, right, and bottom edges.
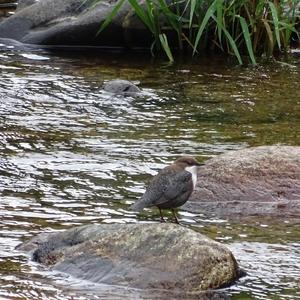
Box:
154, 170, 192, 205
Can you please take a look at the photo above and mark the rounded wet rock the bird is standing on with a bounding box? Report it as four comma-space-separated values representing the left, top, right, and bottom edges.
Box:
19, 223, 240, 295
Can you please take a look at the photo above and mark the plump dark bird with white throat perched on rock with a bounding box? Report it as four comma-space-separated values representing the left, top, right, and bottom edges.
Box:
131, 156, 201, 223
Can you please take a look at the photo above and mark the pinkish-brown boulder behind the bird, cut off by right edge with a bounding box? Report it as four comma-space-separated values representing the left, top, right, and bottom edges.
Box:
184, 146, 300, 217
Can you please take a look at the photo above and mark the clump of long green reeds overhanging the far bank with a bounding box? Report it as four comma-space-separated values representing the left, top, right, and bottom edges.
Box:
95, 0, 300, 64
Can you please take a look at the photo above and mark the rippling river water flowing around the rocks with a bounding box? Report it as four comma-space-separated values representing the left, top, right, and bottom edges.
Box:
0, 45, 300, 299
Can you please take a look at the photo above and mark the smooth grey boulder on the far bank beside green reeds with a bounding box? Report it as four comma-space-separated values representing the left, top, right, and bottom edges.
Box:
0, 0, 152, 47
